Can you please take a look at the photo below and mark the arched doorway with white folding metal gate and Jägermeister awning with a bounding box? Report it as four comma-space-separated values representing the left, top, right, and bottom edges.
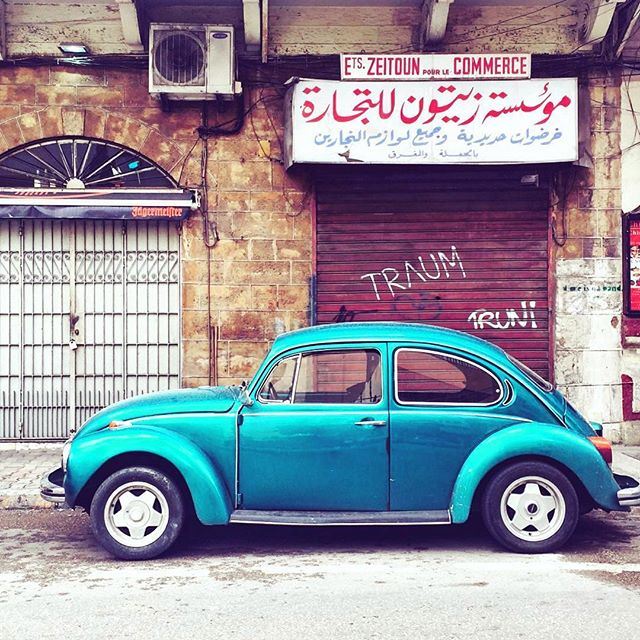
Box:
0, 136, 191, 441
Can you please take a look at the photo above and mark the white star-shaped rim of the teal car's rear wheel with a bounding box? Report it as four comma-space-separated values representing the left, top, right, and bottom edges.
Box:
500, 476, 566, 542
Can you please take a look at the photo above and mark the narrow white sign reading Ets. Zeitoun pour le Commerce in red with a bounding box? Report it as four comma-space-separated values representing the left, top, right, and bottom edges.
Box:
340, 53, 531, 80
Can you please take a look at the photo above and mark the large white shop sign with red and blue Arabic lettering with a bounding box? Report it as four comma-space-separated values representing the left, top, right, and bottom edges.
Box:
286, 78, 578, 166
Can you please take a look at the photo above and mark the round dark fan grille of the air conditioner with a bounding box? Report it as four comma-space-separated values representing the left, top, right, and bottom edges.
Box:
153, 31, 206, 86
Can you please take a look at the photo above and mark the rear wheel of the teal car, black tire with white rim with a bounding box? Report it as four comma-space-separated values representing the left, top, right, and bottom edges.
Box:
482, 462, 580, 553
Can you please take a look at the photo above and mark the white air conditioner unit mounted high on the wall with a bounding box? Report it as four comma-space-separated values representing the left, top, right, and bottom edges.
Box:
149, 23, 242, 100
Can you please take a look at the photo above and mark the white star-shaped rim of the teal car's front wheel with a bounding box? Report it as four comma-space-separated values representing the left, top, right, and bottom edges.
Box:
104, 482, 169, 547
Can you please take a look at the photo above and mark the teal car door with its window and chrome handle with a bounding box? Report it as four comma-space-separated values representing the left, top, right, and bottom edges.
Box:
238, 345, 389, 511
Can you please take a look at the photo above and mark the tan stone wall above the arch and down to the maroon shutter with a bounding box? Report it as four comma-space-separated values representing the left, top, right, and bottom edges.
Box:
0, 67, 311, 385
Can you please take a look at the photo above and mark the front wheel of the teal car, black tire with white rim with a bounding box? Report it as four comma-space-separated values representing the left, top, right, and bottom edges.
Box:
90, 467, 185, 560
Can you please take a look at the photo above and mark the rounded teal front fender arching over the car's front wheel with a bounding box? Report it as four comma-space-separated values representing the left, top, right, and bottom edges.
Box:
64, 425, 233, 525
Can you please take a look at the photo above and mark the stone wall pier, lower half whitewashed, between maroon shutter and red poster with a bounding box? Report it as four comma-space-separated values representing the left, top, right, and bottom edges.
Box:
554, 72, 630, 440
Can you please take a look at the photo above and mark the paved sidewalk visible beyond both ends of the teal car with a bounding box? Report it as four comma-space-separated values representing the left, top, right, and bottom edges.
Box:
0, 444, 640, 509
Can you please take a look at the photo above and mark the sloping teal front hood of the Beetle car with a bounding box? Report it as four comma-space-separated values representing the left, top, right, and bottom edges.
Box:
72, 387, 240, 435
